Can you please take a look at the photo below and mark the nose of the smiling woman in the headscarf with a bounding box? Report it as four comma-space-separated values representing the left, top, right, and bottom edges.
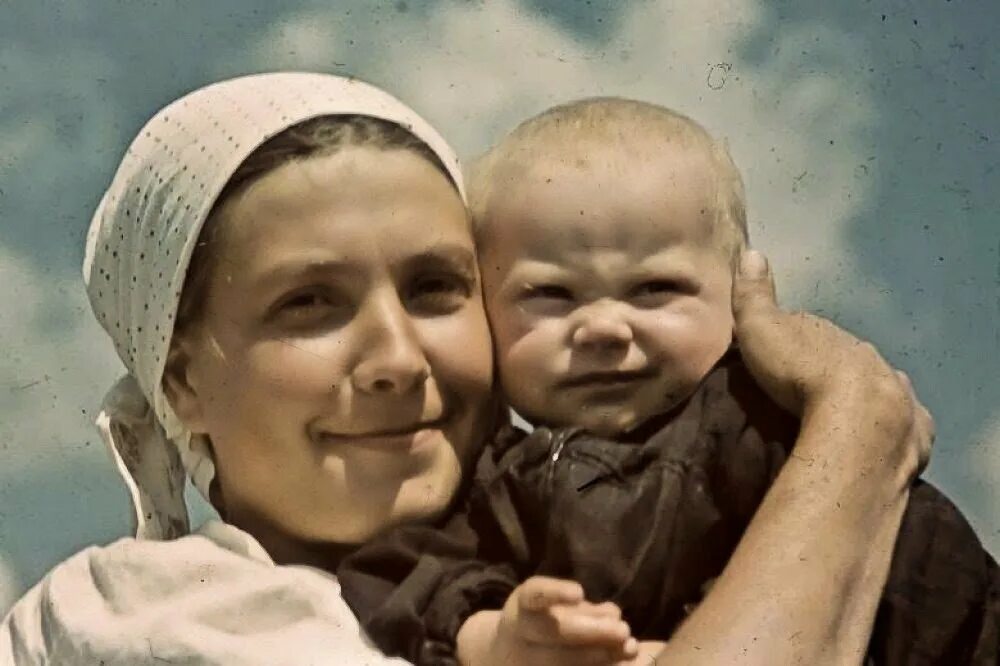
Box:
351, 294, 430, 395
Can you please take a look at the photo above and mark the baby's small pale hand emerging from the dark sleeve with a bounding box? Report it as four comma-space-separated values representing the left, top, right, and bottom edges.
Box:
458, 576, 638, 666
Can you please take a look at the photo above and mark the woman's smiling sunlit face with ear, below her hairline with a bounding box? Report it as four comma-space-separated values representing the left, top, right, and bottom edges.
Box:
168, 148, 494, 559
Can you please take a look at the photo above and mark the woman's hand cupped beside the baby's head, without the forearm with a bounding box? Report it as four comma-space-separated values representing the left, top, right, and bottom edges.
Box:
733, 250, 934, 478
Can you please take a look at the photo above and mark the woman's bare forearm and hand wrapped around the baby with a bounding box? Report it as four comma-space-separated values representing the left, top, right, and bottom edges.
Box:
656, 250, 933, 665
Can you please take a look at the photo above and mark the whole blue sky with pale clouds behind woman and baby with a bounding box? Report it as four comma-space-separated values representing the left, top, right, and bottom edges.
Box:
0, 0, 1000, 610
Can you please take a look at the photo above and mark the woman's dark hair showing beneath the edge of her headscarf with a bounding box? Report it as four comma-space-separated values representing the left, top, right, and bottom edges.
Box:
174, 115, 455, 335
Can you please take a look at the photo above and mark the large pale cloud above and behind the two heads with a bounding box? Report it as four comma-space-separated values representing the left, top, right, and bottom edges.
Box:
234, 0, 886, 308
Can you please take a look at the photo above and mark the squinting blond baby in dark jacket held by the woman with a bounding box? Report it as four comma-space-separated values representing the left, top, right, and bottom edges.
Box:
338, 99, 1000, 664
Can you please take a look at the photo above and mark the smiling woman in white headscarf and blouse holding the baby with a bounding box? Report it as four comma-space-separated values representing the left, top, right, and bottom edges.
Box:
0, 74, 932, 664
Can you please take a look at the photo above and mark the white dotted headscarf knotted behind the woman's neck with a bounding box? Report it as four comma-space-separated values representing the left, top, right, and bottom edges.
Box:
83, 72, 464, 539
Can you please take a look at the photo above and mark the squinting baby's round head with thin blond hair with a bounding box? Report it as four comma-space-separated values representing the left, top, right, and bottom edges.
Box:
470, 98, 746, 436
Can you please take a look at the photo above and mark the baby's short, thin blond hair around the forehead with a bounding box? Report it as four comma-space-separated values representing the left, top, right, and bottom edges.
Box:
468, 97, 747, 257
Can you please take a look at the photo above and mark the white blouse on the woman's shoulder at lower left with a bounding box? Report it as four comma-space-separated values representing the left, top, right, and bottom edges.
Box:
0, 520, 407, 666
